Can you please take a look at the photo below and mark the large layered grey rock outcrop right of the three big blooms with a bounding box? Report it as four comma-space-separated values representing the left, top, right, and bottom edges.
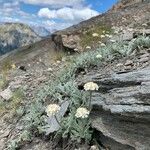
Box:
81, 66, 150, 150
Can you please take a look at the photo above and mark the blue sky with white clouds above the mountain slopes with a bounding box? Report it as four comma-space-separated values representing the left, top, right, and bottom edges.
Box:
0, 0, 117, 30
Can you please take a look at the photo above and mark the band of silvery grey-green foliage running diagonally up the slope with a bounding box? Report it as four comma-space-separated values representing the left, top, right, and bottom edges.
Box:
4, 34, 150, 150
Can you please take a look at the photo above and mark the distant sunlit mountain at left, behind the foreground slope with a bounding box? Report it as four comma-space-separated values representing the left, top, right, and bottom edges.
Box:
0, 23, 41, 55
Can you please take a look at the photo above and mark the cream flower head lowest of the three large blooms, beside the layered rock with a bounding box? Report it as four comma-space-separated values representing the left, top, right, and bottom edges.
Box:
75, 107, 90, 118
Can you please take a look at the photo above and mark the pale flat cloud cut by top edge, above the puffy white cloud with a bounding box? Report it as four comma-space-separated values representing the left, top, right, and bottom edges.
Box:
20, 0, 85, 7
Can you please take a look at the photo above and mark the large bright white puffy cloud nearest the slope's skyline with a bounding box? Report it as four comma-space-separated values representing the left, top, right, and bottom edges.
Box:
38, 7, 99, 22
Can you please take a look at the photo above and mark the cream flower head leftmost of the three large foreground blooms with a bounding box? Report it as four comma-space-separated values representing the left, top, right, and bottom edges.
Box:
46, 104, 60, 116
